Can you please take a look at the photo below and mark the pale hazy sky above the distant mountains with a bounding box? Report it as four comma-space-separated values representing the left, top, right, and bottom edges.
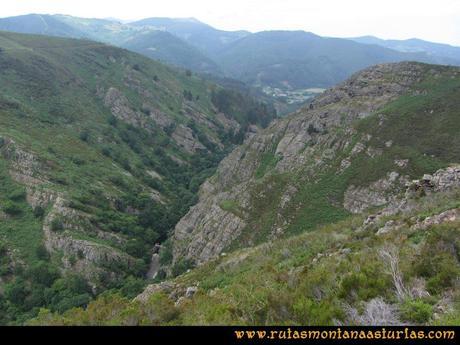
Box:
0, 0, 460, 46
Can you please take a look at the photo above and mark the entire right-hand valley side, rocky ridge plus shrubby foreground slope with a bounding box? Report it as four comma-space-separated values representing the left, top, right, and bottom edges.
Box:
31, 62, 460, 325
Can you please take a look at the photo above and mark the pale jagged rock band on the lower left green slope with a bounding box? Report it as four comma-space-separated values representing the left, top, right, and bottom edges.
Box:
0, 139, 135, 282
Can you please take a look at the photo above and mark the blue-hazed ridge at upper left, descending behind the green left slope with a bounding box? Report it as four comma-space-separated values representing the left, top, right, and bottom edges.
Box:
0, 14, 221, 74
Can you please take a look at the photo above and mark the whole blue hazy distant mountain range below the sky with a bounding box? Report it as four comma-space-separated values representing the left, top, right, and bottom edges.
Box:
0, 14, 460, 90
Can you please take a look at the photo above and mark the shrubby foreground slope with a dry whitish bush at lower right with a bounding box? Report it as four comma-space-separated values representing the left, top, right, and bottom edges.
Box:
30, 170, 460, 326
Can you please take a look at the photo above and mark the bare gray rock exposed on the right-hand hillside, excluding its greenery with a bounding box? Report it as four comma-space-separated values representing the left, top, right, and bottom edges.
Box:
173, 63, 423, 263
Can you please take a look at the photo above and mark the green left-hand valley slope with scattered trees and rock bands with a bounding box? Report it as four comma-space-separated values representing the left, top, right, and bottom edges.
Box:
0, 32, 273, 323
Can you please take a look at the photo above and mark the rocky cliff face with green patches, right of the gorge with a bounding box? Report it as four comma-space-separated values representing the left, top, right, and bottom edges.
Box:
174, 63, 460, 264
